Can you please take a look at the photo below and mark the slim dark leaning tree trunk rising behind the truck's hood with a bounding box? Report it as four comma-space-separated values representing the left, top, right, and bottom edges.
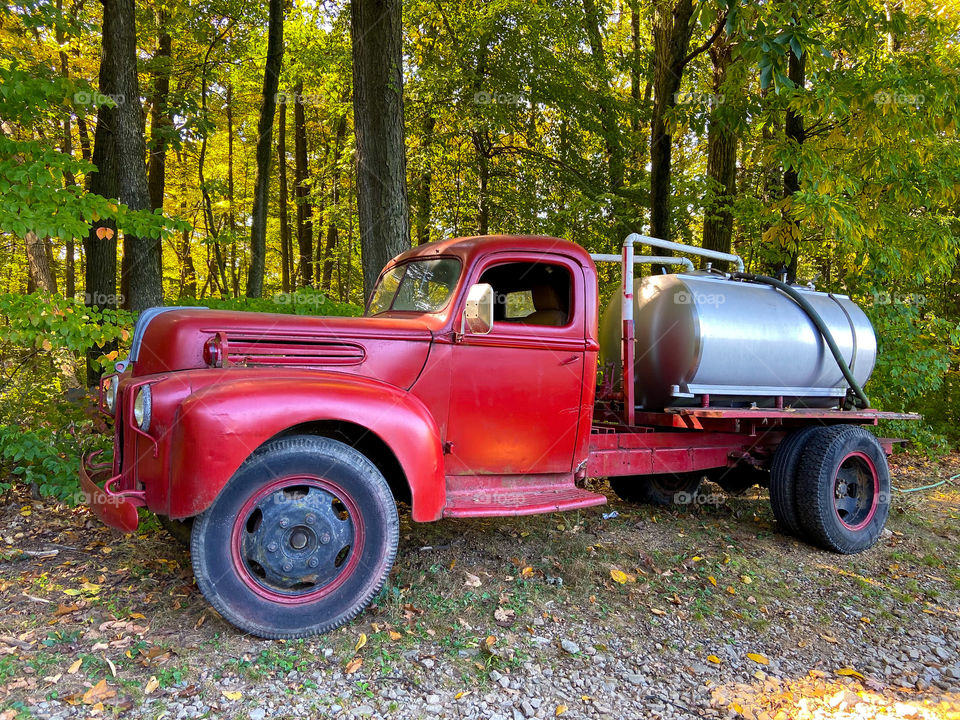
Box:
247, 0, 283, 297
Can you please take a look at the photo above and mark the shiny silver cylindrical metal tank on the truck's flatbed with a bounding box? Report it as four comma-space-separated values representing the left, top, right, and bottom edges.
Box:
600, 272, 877, 410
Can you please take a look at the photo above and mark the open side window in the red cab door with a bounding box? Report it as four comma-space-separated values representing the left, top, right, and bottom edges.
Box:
480, 262, 573, 327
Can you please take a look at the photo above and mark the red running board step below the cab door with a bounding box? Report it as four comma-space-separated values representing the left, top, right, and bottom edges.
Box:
443, 474, 607, 518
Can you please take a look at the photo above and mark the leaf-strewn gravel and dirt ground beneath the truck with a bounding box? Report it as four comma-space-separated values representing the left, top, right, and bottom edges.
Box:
0, 456, 960, 720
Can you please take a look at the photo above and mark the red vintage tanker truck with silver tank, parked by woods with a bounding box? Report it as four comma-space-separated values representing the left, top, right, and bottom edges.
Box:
81, 235, 916, 638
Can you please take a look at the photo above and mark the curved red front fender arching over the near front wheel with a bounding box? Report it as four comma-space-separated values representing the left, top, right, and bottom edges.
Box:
169, 373, 446, 522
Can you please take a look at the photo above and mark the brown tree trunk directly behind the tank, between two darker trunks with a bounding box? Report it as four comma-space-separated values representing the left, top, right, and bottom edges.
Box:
703, 29, 737, 271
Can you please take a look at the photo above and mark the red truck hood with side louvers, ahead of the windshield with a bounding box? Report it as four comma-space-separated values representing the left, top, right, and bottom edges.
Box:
130, 308, 433, 388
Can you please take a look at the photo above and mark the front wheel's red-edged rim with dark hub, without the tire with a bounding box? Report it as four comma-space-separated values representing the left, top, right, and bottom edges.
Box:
230, 475, 364, 605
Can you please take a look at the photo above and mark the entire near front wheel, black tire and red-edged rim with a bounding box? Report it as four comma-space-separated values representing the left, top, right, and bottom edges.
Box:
191, 436, 399, 638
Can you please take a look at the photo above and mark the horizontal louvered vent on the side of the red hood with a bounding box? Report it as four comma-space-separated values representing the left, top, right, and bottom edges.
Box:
226, 333, 365, 368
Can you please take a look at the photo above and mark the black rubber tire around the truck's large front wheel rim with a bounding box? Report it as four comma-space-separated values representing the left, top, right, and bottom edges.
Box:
190, 435, 400, 640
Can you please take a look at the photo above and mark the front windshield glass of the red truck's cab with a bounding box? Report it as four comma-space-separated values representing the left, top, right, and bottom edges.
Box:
367, 258, 460, 315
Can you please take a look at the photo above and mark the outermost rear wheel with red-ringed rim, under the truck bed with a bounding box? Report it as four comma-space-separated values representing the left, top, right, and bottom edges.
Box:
797, 426, 890, 554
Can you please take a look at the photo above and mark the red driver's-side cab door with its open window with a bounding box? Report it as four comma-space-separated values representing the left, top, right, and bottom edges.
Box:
446, 253, 592, 475
